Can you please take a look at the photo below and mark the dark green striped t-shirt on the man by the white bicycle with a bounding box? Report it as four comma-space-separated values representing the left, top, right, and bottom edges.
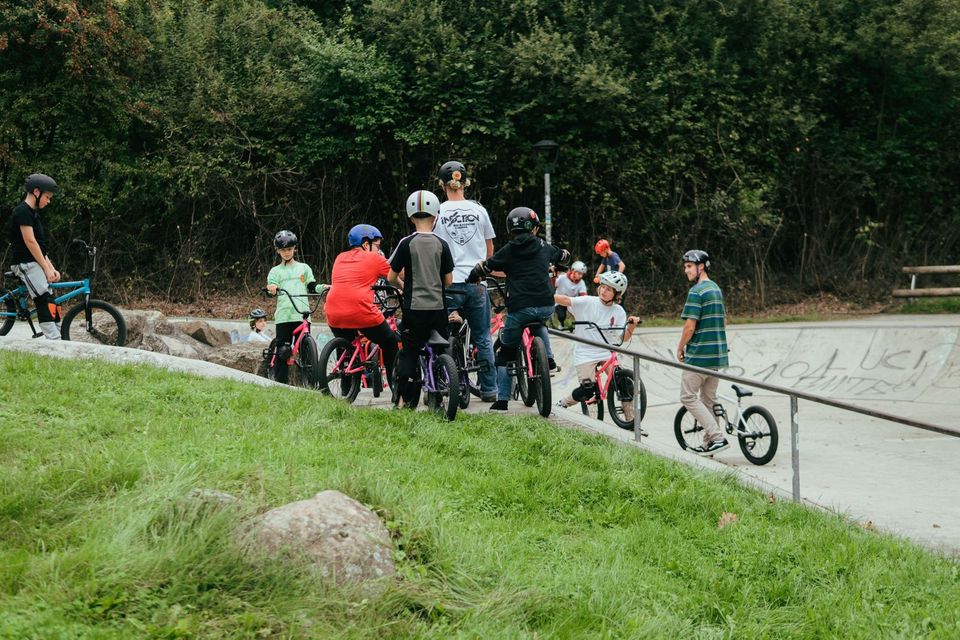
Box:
680, 280, 729, 369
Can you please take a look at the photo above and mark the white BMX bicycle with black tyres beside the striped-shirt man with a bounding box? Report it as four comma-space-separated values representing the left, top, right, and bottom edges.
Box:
673, 385, 780, 465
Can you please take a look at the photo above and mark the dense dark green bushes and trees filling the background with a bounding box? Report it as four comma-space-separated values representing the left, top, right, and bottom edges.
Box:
0, 0, 960, 310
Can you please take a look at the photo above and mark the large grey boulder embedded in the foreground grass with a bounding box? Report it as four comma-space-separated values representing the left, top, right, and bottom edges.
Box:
253, 491, 396, 585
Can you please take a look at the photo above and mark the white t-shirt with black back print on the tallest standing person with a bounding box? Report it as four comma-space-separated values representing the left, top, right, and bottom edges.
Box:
433, 200, 497, 282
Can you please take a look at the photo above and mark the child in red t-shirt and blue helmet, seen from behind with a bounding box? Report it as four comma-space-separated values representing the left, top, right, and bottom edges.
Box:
323, 224, 397, 381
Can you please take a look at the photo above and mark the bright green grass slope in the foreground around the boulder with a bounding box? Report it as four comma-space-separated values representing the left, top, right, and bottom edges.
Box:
0, 352, 960, 639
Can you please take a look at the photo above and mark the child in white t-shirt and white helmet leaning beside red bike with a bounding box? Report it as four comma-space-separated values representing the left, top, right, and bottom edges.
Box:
554, 271, 640, 421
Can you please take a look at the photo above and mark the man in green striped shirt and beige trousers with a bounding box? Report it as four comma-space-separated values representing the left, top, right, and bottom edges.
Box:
677, 249, 730, 456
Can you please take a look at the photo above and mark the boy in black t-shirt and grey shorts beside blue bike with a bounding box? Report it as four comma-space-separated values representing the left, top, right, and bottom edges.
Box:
6, 173, 60, 340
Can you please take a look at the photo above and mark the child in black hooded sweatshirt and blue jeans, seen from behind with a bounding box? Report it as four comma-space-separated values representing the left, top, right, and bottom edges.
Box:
468, 207, 570, 411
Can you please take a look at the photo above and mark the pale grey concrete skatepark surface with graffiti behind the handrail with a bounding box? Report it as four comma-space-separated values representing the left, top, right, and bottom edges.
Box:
0, 315, 960, 555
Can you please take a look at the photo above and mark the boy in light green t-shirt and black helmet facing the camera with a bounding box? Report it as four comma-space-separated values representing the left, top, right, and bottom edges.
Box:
267, 229, 317, 383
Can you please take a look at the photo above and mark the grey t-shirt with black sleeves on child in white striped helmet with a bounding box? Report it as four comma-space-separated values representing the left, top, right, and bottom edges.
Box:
390, 232, 453, 311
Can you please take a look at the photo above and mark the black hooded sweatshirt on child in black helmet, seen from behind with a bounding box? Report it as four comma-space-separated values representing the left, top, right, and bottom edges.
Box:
484, 233, 570, 311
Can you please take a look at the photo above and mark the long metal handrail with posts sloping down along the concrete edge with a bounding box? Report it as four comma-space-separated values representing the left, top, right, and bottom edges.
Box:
547, 329, 960, 502
